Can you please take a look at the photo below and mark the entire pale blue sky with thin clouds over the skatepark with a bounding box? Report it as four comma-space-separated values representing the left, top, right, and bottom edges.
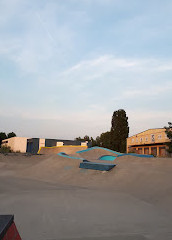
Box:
0, 0, 172, 139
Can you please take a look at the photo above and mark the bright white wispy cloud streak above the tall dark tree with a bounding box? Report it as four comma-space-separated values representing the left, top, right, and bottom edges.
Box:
53, 55, 172, 91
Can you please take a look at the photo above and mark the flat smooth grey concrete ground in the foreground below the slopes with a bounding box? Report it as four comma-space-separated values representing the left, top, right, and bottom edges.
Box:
0, 176, 172, 240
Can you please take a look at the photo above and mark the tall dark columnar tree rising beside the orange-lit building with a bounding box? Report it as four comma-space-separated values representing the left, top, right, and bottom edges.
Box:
111, 109, 129, 152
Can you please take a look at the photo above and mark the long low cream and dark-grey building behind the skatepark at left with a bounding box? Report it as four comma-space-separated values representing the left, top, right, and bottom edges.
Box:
1, 137, 89, 154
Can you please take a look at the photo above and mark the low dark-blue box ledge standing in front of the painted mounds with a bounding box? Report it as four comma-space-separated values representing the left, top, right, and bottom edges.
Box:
79, 162, 116, 171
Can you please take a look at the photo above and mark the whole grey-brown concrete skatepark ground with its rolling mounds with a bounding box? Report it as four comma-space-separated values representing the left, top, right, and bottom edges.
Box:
0, 149, 172, 240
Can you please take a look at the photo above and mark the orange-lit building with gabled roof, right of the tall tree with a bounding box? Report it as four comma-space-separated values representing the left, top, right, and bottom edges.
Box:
127, 128, 170, 157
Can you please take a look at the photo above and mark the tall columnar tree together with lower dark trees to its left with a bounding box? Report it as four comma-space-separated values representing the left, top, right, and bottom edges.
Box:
76, 109, 129, 152
